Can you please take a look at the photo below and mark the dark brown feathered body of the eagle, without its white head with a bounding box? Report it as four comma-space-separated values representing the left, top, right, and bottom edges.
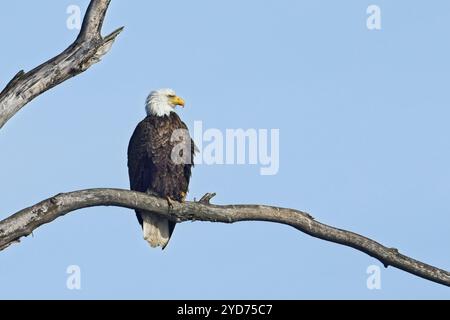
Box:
128, 112, 195, 247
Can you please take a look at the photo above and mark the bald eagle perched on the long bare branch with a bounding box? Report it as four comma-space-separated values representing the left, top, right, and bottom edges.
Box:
128, 89, 195, 249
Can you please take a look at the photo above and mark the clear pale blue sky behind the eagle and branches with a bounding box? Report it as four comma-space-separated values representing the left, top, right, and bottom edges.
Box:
0, 0, 450, 299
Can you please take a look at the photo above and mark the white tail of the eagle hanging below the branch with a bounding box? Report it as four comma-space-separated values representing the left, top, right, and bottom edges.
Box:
141, 213, 170, 249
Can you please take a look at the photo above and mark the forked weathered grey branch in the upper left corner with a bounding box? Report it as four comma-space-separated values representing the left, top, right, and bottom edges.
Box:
0, 0, 123, 129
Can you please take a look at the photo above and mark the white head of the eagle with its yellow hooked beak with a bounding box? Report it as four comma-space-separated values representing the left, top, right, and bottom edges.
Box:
145, 89, 184, 117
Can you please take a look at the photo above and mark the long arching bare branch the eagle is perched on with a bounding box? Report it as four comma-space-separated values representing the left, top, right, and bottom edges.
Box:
0, 189, 450, 286
